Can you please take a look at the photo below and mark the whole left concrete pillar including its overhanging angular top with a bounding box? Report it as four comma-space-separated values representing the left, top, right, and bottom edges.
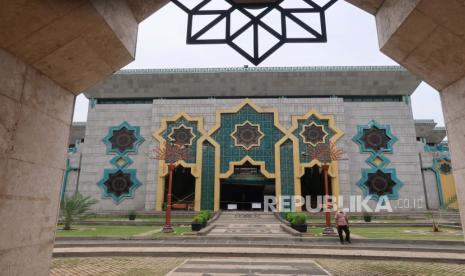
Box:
0, 0, 169, 276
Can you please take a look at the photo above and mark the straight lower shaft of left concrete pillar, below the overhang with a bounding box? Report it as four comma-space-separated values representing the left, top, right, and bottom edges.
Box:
0, 49, 74, 275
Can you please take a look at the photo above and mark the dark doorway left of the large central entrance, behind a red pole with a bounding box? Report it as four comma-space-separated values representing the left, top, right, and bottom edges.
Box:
163, 166, 195, 210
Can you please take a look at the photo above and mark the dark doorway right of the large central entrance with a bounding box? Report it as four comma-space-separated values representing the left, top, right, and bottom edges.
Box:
300, 165, 332, 210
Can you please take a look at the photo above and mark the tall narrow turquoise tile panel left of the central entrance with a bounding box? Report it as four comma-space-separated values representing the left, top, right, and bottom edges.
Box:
200, 142, 215, 210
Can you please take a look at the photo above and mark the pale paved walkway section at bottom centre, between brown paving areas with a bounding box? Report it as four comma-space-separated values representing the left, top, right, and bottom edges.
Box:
168, 258, 331, 276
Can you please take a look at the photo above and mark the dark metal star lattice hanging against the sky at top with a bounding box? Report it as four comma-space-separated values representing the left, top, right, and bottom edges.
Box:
172, 0, 337, 65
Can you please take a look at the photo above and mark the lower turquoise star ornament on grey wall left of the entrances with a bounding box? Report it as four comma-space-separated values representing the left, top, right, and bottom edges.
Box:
97, 169, 141, 204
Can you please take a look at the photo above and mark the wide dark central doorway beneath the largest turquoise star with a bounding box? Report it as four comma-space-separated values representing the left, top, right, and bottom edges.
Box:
220, 163, 275, 210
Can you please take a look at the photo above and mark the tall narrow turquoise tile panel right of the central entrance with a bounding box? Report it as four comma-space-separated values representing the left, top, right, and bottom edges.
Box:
281, 140, 295, 196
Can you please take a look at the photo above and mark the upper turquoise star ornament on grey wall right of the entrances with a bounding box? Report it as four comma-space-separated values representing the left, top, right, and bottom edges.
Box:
353, 121, 397, 154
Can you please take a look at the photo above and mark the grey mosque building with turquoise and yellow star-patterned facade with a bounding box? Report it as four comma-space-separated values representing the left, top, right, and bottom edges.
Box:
62, 66, 457, 212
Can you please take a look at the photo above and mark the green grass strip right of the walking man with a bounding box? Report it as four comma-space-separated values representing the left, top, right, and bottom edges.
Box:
350, 227, 463, 241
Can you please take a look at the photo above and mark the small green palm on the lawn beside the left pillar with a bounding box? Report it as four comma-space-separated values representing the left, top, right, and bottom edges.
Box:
60, 193, 98, 230
